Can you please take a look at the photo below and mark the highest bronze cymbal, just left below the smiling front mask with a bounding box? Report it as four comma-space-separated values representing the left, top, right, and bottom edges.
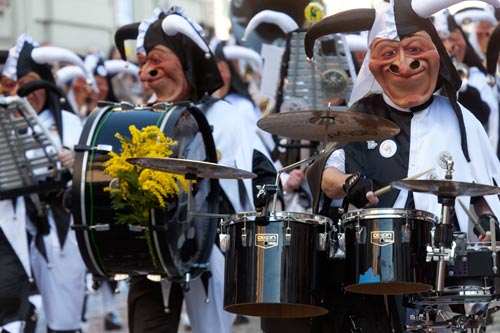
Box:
257, 108, 400, 142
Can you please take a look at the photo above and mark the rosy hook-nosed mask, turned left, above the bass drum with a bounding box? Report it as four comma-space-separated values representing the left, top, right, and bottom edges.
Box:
137, 45, 191, 102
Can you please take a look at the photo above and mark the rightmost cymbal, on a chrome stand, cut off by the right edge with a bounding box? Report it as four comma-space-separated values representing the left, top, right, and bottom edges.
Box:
391, 179, 500, 197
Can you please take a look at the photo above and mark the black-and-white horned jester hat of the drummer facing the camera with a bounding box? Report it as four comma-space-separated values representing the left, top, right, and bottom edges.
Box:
304, 0, 500, 160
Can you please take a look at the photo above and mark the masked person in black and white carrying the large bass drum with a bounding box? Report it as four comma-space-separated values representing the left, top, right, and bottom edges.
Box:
115, 6, 278, 333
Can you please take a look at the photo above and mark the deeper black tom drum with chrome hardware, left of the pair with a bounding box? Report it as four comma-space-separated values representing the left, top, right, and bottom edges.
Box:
221, 212, 333, 318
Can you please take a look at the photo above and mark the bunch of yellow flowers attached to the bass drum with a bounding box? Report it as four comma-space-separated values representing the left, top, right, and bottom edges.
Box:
103, 125, 188, 226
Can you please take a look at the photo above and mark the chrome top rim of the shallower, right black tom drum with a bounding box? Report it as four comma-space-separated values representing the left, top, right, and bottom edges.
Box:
341, 208, 438, 224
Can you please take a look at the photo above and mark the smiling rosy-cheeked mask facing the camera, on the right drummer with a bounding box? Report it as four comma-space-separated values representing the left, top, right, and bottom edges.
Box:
369, 31, 440, 108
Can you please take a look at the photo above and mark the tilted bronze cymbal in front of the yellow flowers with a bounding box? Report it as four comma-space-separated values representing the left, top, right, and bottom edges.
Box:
127, 157, 257, 179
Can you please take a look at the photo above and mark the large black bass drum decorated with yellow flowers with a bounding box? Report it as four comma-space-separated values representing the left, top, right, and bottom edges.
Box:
72, 104, 218, 282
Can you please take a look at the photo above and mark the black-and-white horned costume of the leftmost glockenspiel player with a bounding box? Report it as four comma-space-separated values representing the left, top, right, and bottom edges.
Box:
3, 34, 86, 332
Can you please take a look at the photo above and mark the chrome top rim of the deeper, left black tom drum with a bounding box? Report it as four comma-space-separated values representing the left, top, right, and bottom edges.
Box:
222, 211, 333, 226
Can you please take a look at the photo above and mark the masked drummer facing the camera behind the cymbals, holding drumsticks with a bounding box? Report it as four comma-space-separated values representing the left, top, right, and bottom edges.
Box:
305, 0, 500, 240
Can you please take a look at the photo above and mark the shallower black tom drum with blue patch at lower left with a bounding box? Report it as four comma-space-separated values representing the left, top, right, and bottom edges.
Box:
342, 208, 437, 295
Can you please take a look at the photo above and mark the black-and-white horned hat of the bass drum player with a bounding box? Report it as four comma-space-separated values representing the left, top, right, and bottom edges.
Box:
115, 6, 223, 101
